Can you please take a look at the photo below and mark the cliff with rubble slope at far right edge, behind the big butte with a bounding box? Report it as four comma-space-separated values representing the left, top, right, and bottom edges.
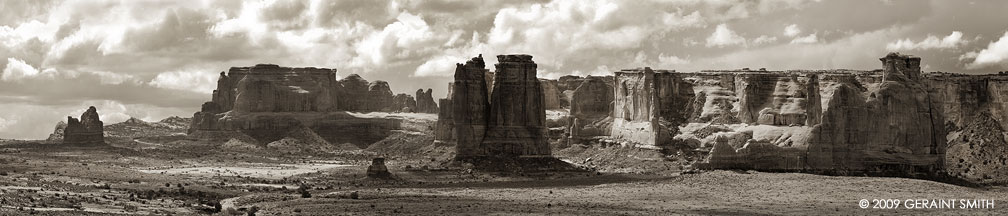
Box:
924, 74, 1008, 184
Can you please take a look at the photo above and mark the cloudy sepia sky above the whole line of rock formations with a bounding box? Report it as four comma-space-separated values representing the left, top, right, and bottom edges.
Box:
0, 0, 1008, 138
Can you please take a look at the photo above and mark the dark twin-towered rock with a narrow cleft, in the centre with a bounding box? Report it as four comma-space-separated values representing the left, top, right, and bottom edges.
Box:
451, 55, 551, 159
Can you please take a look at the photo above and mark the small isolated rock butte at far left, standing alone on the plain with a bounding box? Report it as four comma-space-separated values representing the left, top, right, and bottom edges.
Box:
64, 106, 105, 145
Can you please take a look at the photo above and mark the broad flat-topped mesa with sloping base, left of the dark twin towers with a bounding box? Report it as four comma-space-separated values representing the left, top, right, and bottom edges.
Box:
188, 65, 417, 147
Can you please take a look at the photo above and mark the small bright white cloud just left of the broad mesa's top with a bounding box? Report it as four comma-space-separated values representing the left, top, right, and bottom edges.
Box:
147, 70, 220, 93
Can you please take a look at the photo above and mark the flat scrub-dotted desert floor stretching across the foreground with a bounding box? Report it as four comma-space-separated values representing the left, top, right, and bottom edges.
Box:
0, 137, 1008, 215
